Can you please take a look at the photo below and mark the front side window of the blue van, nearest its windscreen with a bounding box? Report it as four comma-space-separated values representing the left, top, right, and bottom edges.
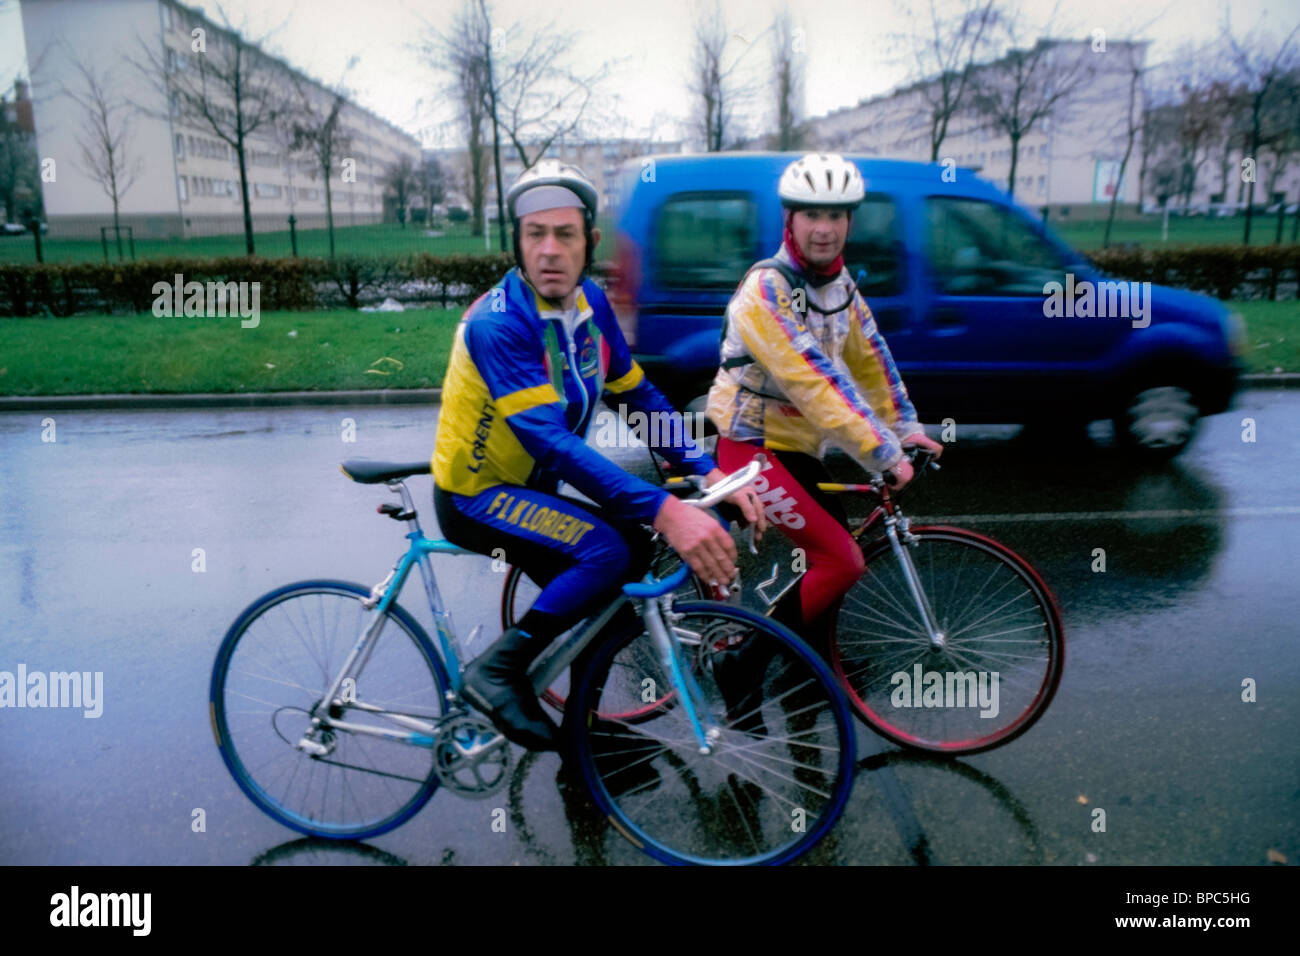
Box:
926, 196, 1065, 295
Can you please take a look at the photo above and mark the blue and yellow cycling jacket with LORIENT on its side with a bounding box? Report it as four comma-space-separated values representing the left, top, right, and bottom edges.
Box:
433, 269, 716, 524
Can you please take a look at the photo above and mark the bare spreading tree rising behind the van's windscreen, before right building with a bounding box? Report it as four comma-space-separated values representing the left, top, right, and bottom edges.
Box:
971, 17, 1096, 195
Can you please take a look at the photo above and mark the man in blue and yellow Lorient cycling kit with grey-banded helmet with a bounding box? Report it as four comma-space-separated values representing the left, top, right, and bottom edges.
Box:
433, 160, 766, 749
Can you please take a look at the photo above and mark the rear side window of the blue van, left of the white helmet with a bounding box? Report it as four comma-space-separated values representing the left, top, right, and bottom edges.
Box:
654, 193, 758, 289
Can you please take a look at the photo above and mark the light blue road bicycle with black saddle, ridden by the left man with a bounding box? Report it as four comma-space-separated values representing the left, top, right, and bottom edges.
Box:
209, 460, 855, 864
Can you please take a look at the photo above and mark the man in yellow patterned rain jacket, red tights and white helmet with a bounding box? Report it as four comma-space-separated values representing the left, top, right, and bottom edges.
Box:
709, 153, 943, 652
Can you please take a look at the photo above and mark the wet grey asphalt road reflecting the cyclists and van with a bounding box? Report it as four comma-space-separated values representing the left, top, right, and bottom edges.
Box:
0, 392, 1300, 868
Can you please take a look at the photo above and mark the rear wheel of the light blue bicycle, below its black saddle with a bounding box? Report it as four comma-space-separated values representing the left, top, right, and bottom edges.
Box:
209, 580, 449, 839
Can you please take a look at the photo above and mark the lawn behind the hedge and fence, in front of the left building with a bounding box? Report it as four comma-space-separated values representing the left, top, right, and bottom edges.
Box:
0, 214, 612, 263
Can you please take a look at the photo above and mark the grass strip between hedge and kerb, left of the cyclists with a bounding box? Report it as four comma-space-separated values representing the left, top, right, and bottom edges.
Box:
0, 308, 462, 395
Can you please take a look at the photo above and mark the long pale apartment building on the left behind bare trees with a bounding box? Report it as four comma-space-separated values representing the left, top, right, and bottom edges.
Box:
22, 0, 420, 238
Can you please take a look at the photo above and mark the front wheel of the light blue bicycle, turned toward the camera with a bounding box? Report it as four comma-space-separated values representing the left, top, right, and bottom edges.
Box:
567, 601, 855, 864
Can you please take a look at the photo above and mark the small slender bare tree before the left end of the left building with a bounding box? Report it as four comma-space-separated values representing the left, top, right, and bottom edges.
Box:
64, 55, 143, 258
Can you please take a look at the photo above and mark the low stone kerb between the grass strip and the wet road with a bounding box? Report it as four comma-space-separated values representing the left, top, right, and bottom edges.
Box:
0, 372, 1300, 411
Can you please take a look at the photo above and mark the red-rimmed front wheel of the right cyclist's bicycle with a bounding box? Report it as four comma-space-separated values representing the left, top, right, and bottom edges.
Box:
829, 527, 1065, 754
